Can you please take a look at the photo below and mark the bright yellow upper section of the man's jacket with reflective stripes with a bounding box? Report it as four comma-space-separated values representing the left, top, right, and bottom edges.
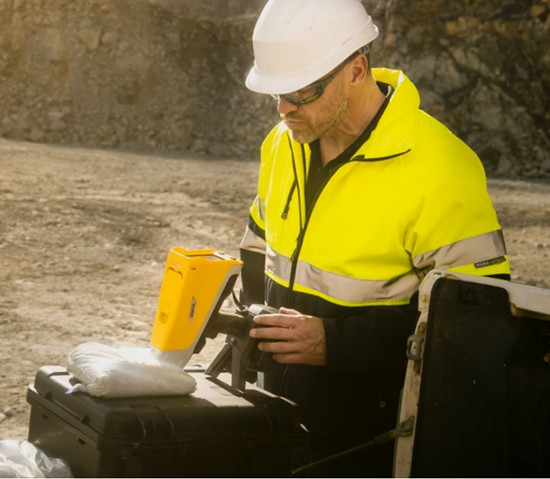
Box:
242, 69, 509, 307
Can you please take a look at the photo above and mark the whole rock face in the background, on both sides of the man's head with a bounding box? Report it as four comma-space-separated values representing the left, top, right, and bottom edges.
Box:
0, 0, 550, 178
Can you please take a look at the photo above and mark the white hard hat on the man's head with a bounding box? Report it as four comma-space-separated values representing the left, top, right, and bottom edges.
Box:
246, 0, 378, 94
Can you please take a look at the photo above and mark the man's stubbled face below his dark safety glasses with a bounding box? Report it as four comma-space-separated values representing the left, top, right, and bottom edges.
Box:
277, 65, 349, 143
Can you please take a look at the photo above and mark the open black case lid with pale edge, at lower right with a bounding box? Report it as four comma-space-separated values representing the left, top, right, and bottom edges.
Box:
394, 272, 550, 477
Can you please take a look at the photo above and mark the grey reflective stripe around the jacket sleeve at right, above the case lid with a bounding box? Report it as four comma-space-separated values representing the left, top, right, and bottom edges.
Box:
413, 230, 506, 272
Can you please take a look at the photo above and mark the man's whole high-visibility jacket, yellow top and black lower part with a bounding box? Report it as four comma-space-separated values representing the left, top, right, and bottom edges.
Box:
241, 69, 510, 472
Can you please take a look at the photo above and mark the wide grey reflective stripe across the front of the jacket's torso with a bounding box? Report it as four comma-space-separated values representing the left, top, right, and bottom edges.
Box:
266, 247, 419, 305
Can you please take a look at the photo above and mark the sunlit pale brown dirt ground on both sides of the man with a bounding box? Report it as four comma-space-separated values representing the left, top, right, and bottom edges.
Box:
0, 140, 550, 439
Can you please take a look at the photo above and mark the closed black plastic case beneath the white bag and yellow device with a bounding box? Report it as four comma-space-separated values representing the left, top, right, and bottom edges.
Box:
27, 366, 307, 477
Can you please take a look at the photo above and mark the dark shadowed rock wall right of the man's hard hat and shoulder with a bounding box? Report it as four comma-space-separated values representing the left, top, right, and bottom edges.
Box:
376, 0, 550, 177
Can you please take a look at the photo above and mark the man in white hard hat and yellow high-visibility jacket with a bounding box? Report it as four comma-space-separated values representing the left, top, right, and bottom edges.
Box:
241, 0, 509, 477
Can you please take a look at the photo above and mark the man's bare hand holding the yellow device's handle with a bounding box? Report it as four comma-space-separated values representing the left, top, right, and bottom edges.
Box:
250, 308, 327, 366
